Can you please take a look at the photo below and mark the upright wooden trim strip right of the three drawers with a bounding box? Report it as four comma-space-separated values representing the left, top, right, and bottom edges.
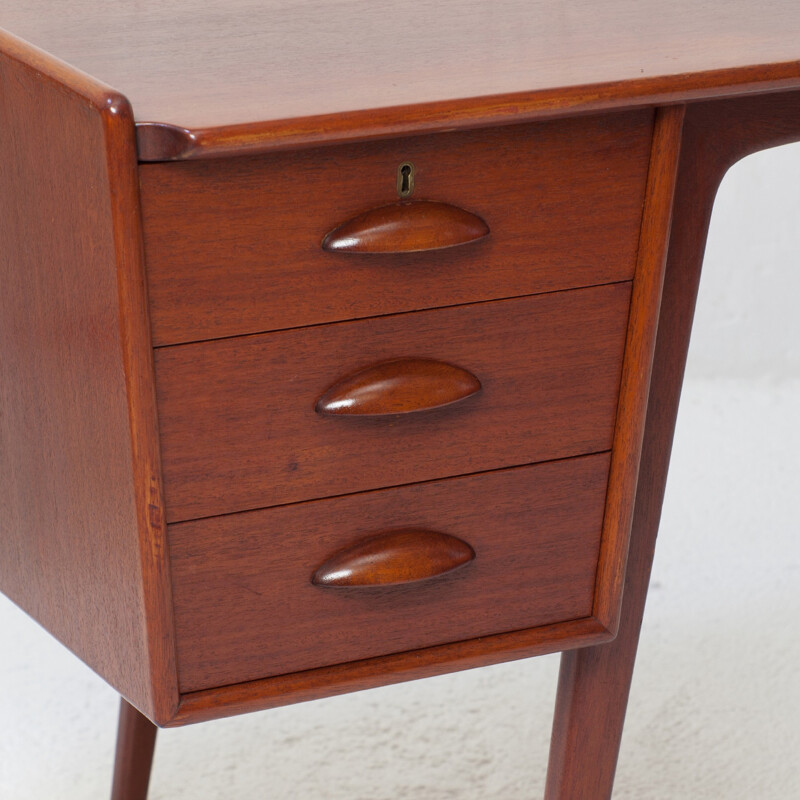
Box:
594, 106, 684, 631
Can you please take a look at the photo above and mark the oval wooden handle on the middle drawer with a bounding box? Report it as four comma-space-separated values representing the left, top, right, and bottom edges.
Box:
316, 358, 481, 416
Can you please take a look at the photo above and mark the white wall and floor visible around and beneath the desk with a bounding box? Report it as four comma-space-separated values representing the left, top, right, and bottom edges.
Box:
0, 141, 800, 800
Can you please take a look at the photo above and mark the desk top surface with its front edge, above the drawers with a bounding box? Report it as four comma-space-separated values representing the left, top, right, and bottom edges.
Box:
0, 0, 800, 161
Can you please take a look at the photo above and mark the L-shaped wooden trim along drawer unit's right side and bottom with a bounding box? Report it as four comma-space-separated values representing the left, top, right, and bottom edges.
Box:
162, 106, 684, 724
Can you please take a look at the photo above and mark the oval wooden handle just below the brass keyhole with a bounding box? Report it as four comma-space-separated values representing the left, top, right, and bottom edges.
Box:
322, 200, 489, 253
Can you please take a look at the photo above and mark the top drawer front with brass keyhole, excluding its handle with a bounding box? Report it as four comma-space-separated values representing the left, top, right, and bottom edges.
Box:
140, 110, 653, 345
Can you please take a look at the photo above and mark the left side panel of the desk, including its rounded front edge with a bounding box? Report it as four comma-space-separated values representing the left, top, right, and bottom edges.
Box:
0, 34, 178, 720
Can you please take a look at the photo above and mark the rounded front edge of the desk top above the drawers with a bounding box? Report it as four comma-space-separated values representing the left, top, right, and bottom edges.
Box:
136, 61, 800, 162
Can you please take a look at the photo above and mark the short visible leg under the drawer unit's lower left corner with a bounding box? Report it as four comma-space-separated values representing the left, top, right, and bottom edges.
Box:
111, 698, 158, 800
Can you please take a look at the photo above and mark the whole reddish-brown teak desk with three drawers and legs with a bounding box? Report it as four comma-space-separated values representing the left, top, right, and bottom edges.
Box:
0, 0, 800, 800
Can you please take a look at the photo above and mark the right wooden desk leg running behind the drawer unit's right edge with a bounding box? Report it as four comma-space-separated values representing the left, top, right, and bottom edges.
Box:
545, 104, 700, 800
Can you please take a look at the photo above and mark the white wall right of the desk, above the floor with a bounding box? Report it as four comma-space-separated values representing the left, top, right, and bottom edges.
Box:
688, 145, 800, 378
